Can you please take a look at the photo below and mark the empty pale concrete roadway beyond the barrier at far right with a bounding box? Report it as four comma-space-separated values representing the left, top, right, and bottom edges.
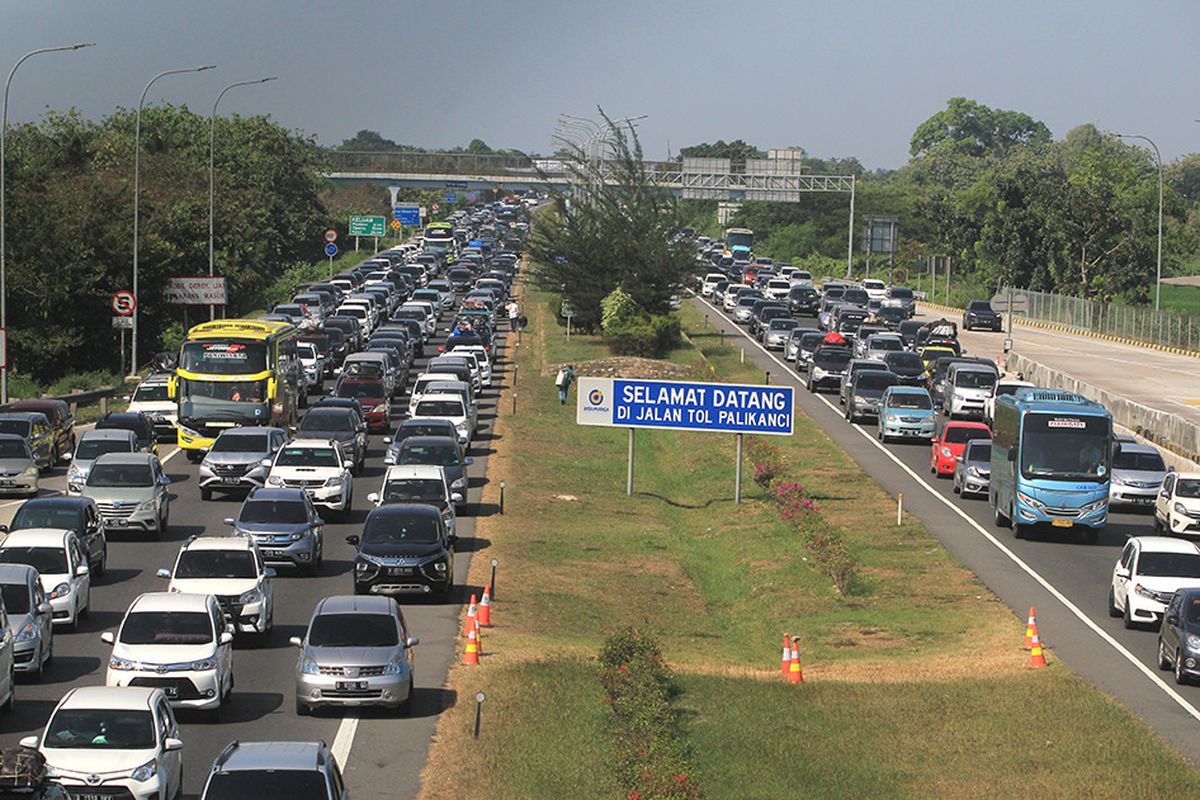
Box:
916, 306, 1200, 425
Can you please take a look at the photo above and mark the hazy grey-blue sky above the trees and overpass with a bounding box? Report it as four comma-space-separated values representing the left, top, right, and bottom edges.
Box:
0, 0, 1200, 167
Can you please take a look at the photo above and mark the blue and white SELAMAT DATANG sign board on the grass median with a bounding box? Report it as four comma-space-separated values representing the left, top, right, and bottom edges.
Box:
575, 378, 794, 435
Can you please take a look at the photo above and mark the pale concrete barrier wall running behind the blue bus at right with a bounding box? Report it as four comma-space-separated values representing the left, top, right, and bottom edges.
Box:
1008, 351, 1200, 471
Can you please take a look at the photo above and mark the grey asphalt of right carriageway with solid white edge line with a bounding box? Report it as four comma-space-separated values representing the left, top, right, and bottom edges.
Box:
692, 297, 1200, 763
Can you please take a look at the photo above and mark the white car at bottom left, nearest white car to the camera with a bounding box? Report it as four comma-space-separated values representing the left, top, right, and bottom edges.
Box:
20, 686, 184, 800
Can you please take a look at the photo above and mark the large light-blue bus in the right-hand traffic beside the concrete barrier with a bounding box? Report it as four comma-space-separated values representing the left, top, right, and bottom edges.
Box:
988, 389, 1114, 543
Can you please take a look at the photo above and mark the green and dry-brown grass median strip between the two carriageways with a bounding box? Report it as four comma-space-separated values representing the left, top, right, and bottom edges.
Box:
422, 284, 1200, 799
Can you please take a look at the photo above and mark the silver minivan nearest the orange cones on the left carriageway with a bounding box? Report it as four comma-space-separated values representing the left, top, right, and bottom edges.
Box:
290, 595, 418, 715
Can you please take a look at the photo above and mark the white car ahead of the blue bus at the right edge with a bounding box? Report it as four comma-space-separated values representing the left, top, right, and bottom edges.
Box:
1109, 536, 1200, 627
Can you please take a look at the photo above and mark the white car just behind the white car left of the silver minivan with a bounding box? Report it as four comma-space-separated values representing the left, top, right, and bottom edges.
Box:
158, 536, 275, 636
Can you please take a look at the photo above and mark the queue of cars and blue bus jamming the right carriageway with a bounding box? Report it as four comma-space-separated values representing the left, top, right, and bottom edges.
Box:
695, 229, 1200, 684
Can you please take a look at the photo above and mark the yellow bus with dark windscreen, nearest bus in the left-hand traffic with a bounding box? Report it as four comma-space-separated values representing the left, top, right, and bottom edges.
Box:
170, 319, 304, 461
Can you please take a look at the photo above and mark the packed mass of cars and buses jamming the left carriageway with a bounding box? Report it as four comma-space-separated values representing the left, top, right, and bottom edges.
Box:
0, 196, 534, 800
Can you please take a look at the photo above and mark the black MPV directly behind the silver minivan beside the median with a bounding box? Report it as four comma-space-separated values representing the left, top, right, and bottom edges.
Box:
346, 503, 457, 599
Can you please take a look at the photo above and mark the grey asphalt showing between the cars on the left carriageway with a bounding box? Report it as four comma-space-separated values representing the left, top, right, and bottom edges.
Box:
0, 314, 508, 800
